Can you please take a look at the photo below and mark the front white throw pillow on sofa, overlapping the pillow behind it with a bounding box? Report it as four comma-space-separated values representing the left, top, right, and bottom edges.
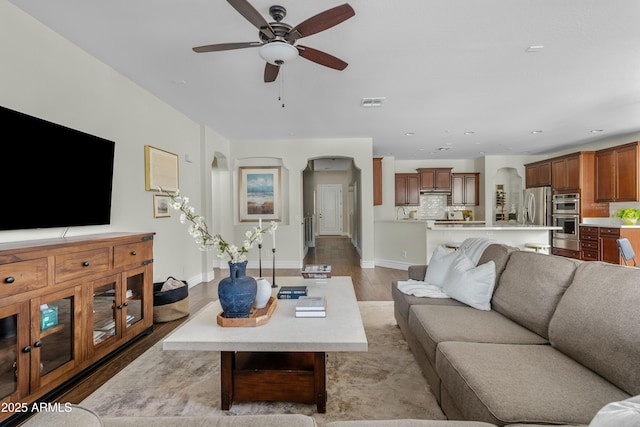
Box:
442, 252, 496, 311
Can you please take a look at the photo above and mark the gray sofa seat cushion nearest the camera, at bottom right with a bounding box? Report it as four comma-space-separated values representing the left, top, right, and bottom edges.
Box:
436, 342, 630, 425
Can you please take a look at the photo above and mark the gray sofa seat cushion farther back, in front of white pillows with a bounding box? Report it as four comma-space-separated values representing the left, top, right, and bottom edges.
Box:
409, 305, 548, 365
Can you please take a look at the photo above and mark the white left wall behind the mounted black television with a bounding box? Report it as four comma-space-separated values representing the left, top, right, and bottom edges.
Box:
0, 0, 228, 288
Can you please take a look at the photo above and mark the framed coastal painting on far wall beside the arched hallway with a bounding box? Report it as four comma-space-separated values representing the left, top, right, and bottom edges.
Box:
239, 166, 282, 221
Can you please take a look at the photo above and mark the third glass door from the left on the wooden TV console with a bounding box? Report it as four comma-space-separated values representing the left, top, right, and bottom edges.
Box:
92, 276, 120, 347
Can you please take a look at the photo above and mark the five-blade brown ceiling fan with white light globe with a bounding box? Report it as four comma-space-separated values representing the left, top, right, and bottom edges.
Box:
193, 0, 356, 83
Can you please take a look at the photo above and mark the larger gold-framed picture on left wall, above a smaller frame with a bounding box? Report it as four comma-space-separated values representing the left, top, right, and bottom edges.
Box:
144, 145, 179, 192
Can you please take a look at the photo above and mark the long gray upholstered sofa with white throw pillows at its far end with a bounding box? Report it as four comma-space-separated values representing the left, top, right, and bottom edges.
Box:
392, 244, 640, 426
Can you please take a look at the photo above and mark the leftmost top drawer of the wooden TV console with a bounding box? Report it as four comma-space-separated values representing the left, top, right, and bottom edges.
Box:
0, 258, 47, 296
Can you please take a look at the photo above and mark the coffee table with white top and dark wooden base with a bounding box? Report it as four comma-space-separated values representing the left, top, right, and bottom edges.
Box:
163, 276, 368, 413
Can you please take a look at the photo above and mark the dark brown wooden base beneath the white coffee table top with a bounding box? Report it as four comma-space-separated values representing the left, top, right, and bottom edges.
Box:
220, 351, 327, 413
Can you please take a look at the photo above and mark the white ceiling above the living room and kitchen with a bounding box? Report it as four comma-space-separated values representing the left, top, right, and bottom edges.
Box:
10, 0, 640, 159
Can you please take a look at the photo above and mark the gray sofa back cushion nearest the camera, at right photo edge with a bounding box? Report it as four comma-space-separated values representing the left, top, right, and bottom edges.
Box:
549, 262, 640, 395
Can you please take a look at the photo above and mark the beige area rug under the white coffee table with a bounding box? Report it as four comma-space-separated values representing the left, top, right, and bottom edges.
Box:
82, 301, 445, 426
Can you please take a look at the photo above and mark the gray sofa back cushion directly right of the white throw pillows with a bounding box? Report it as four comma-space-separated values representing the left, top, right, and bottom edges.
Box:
491, 251, 581, 338
